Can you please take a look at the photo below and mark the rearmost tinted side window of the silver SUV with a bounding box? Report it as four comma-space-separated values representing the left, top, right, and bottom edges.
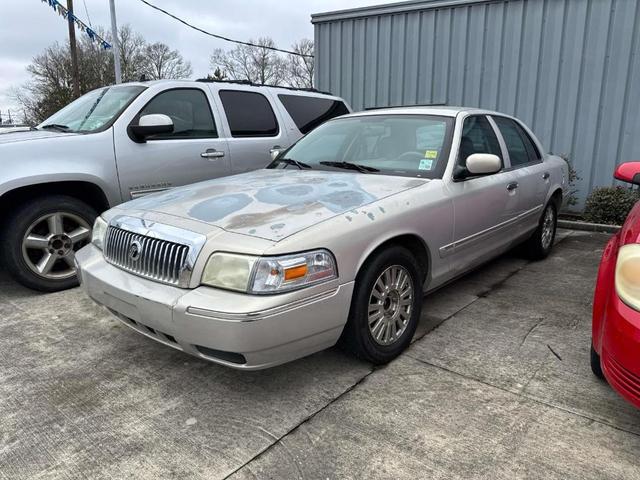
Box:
278, 94, 349, 134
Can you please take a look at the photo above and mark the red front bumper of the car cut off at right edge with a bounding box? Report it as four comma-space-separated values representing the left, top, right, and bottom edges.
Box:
600, 289, 640, 408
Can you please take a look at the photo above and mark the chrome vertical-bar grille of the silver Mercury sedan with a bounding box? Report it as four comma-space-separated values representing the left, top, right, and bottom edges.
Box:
104, 226, 189, 286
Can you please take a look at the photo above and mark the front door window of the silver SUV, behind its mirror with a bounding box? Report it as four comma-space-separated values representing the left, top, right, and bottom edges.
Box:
138, 88, 218, 140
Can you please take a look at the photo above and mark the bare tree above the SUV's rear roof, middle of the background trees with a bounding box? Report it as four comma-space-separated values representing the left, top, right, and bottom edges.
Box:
210, 37, 286, 85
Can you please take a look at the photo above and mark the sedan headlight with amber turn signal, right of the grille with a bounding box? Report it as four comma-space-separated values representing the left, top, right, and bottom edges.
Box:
202, 250, 338, 294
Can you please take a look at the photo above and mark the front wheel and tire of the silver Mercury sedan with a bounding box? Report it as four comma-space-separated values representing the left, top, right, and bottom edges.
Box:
340, 246, 424, 364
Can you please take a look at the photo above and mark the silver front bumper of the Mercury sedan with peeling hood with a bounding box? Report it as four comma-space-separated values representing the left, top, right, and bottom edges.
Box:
76, 245, 353, 370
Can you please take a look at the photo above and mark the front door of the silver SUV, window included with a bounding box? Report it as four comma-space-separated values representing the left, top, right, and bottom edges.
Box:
115, 87, 231, 200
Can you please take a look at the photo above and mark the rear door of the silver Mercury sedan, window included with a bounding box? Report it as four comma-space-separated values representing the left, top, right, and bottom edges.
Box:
492, 116, 550, 234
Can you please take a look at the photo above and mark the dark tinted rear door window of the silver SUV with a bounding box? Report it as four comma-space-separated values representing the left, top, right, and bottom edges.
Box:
220, 90, 278, 137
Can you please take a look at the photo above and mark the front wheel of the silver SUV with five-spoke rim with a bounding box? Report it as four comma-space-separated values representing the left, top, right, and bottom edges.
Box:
1, 195, 97, 292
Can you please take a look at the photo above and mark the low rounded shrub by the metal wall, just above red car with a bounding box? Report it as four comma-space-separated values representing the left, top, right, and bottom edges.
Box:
584, 187, 640, 225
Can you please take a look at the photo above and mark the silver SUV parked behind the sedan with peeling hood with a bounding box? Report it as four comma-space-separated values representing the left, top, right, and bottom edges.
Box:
0, 80, 350, 291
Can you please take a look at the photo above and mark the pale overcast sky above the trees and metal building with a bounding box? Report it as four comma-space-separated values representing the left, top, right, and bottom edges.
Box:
0, 0, 387, 119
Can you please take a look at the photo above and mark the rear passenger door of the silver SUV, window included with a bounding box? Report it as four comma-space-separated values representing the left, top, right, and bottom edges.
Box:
218, 89, 290, 173
